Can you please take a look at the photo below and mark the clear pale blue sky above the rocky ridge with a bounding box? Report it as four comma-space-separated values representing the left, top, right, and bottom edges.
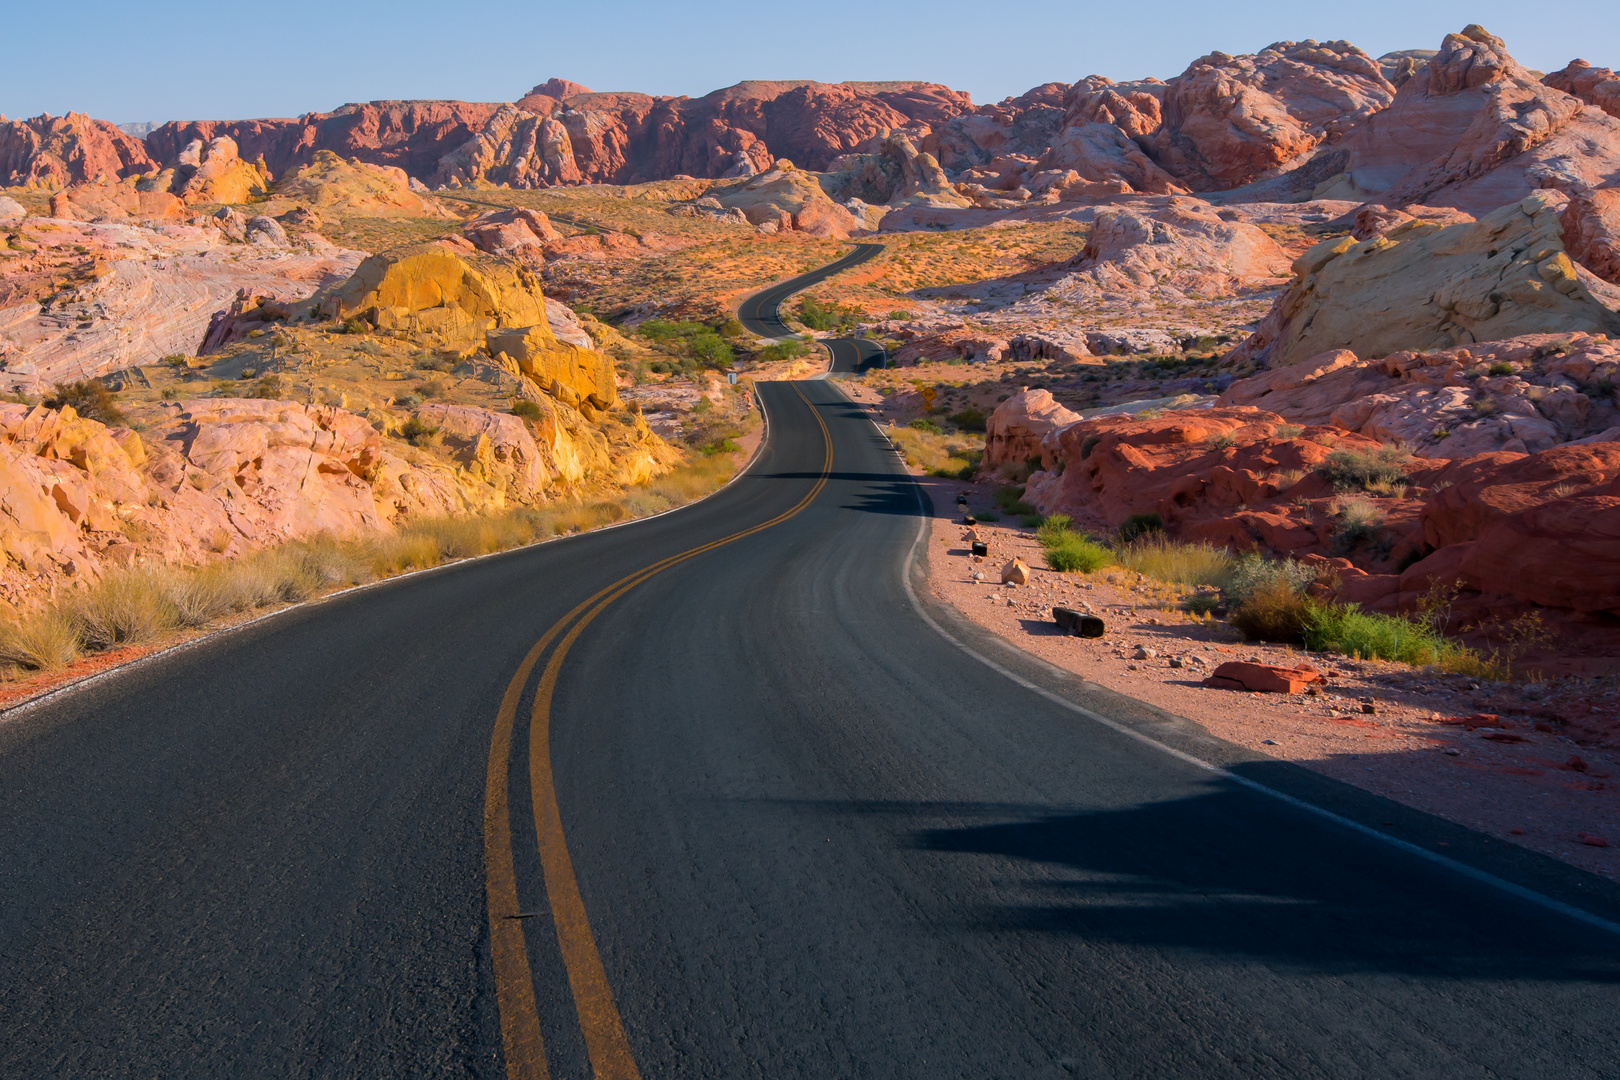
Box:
0, 0, 1620, 123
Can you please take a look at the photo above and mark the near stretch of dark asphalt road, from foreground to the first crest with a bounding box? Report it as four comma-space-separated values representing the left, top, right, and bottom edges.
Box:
0, 375, 1620, 1080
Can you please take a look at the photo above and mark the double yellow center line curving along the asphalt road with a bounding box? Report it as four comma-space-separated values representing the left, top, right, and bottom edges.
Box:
484, 385, 833, 1080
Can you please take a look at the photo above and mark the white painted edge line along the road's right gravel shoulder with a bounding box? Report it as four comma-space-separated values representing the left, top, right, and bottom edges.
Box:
833, 382, 1620, 936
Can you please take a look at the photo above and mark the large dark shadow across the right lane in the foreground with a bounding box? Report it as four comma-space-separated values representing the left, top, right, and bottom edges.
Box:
745, 782, 1620, 984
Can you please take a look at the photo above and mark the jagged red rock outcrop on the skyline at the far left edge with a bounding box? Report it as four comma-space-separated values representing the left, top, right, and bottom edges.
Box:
0, 112, 156, 188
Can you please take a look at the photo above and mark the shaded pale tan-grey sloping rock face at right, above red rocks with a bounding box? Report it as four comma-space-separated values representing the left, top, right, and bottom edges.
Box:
1231, 193, 1620, 368
